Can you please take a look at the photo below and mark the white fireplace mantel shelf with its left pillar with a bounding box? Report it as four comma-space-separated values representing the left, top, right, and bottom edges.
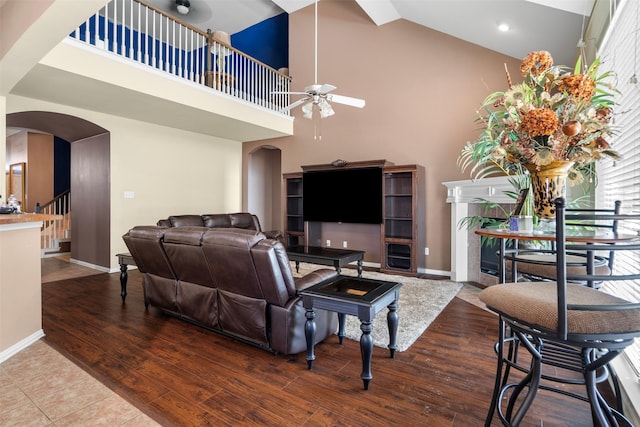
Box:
442, 176, 514, 282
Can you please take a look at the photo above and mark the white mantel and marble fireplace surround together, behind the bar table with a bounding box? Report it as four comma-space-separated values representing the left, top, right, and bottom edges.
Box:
442, 176, 514, 285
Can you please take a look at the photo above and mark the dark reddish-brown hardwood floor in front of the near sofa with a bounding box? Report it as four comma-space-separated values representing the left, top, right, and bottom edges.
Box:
42, 270, 604, 427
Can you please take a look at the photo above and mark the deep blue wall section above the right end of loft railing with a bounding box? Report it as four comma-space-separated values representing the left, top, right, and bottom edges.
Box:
231, 12, 289, 70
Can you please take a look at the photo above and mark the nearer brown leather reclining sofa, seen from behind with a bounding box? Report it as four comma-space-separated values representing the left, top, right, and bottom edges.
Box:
123, 226, 337, 354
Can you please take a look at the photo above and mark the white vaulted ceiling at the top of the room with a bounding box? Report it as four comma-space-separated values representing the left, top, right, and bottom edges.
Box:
146, 0, 594, 65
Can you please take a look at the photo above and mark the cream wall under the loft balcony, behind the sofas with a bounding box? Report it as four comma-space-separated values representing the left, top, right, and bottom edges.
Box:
6, 95, 242, 270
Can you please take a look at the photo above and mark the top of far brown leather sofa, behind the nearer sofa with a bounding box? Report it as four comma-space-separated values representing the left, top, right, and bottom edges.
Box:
156, 212, 284, 244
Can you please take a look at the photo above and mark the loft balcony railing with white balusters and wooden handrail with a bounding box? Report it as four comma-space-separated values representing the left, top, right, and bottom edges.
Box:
69, 0, 291, 115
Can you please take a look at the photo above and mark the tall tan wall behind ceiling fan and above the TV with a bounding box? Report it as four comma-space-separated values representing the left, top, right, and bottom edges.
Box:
243, 0, 520, 271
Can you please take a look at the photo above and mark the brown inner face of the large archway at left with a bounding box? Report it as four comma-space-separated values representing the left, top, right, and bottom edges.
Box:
6, 111, 111, 269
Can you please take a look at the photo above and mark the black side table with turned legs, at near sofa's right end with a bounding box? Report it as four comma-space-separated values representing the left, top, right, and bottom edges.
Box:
300, 276, 402, 390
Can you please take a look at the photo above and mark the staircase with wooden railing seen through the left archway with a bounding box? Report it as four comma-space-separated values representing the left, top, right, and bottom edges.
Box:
36, 191, 71, 258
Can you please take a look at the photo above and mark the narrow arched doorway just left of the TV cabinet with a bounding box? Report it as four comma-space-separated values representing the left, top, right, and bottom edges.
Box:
247, 145, 282, 230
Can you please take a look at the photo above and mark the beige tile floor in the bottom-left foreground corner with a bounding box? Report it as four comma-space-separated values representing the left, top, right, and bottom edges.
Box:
0, 340, 158, 427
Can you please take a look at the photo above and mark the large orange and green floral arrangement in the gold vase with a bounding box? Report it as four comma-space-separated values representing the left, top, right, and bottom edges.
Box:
458, 51, 618, 185
